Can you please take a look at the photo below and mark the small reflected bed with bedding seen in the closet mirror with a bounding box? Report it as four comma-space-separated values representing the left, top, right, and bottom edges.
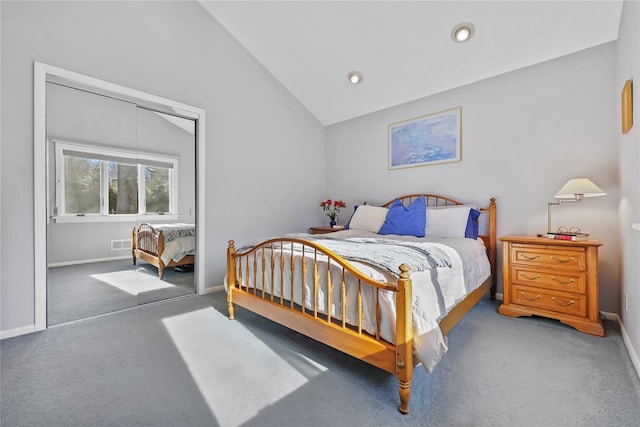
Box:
131, 223, 196, 279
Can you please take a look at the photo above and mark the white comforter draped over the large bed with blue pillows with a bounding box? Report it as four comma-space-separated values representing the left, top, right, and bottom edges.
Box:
229, 230, 491, 372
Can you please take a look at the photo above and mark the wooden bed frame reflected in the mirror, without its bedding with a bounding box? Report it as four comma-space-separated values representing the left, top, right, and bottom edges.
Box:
131, 223, 195, 279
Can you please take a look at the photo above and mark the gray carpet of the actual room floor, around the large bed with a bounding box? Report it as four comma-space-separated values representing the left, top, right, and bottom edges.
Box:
0, 292, 640, 427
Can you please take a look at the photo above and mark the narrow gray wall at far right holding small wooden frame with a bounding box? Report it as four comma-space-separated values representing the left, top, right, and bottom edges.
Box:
615, 1, 640, 369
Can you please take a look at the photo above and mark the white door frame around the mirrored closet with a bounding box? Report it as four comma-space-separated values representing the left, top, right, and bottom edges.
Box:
33, 61, 206, 331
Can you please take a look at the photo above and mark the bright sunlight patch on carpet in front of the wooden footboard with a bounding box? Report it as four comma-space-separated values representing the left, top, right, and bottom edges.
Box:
163, 308, 327, 426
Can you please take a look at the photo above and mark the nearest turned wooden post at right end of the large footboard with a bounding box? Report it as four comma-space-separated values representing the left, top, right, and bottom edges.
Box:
396, 264, 413, 415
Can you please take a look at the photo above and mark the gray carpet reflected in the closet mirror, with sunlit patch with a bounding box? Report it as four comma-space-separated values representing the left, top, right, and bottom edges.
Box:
47, 259, 195, 326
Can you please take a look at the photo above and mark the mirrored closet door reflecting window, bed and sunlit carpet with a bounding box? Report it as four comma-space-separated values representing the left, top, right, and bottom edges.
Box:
46, 82, 196, 326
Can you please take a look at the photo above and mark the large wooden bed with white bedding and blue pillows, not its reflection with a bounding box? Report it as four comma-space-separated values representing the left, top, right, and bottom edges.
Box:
225, 194, 496, 414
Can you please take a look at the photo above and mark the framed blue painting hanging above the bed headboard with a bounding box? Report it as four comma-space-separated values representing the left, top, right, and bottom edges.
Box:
389, 107, 462, 169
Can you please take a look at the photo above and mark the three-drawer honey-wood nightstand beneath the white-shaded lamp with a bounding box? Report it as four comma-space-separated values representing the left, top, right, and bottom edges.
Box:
498, 236, 604, 336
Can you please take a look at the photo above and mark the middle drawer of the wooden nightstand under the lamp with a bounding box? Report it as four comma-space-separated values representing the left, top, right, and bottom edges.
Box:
511, 265, 587, 294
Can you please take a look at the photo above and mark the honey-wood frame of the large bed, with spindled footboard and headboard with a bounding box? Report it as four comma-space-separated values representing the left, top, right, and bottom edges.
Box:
227, 194, 497, 414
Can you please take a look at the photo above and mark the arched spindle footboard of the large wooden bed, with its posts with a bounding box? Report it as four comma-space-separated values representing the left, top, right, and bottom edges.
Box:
227, 238, 415, 413
